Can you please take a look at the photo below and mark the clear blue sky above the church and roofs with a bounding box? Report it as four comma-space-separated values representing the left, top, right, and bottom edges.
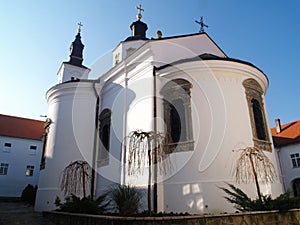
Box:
0, 0, 300, 126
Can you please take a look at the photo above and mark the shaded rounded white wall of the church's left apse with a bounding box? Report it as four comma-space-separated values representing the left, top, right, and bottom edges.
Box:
35, 82, 99, 211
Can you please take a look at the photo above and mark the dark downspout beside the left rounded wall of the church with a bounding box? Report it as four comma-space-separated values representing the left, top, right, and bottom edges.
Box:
91, 80, 100, 200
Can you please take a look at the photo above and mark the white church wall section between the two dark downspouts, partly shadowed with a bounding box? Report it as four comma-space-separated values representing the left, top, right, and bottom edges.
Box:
97, 60, 153, 200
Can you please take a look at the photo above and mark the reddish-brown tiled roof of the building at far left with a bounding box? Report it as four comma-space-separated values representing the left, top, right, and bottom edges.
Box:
0, 114, 44, 140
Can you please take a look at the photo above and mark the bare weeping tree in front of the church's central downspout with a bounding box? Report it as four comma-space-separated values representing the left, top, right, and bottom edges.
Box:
124, 130, 171, 215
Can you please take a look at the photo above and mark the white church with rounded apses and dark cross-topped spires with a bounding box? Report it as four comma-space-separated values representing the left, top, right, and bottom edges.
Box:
35, 8, 282, 214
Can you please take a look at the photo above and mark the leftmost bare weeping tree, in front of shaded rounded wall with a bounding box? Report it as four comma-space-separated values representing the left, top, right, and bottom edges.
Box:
60, 160, 91, 197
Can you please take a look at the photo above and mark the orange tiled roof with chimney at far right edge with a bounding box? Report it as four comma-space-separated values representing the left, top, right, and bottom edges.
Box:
271, 120, 300, 146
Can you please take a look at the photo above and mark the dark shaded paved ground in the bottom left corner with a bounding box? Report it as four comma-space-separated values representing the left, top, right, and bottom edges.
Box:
0, 202, 55, 225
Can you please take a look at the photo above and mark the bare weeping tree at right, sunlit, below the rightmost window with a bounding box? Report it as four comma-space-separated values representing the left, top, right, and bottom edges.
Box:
234, 147, 277, 201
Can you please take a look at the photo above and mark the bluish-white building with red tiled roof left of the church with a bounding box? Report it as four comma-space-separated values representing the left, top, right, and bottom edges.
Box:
0, 114, 44, 197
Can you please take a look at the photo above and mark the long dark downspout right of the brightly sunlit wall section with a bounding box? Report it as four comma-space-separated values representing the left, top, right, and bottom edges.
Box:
153, 66, 157, 213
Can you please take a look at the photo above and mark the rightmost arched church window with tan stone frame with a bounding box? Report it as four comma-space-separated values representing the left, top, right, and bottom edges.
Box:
243, 79, 272, 151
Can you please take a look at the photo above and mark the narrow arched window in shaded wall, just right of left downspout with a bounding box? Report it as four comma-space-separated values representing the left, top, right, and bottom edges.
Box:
97, 109, 111, 167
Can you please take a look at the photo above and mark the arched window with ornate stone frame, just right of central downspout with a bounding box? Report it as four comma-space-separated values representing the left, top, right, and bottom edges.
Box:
161, 79, 194, 152
